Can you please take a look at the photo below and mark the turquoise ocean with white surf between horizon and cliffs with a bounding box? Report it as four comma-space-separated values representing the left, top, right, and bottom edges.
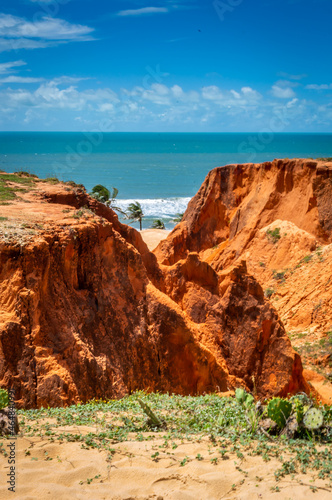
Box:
0, 132, 332, 229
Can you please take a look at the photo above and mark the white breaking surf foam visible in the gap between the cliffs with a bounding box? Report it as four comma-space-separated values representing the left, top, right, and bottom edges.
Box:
114, 198, 191, 219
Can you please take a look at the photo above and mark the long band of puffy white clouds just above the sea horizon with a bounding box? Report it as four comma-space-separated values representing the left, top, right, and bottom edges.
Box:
0, 76, 332, 131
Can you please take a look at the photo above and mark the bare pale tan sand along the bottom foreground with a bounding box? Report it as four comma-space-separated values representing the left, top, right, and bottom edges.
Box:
0, 432, 332, 500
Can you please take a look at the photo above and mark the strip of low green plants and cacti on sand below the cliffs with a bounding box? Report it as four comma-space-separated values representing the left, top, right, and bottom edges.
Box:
0, 389, 332, 491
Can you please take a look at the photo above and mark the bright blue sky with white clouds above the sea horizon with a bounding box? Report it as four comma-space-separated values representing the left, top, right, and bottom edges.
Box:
0, 0, 332, 132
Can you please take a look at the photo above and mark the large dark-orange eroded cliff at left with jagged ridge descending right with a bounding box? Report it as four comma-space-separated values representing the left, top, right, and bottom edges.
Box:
0, 174, 310, 407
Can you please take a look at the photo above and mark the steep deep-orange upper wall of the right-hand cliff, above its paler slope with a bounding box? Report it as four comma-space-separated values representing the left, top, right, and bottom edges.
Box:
155, 160, 332, 269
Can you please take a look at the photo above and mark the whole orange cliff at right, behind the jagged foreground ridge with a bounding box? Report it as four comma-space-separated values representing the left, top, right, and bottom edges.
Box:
154, 159, 332, 403
